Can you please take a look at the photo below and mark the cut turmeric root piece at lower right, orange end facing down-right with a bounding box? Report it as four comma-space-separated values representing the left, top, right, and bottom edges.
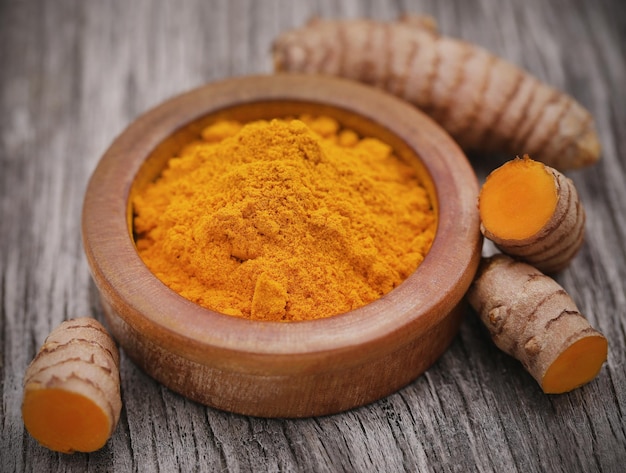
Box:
467, 254, 608, 394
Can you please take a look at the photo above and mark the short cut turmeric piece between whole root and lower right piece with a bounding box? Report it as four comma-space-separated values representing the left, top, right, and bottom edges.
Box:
478, 155, 585, 273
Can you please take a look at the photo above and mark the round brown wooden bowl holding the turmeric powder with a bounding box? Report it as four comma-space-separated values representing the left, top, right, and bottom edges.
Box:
82, 75, 482, 417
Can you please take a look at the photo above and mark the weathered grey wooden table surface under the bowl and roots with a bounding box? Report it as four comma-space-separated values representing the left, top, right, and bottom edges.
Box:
0, 0, 626, 472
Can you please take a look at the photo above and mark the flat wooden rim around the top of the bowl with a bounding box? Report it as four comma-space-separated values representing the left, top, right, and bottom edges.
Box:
82, 74, 482, 366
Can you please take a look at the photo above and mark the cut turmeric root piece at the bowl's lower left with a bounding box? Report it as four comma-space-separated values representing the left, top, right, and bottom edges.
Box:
22, 317, 122, 453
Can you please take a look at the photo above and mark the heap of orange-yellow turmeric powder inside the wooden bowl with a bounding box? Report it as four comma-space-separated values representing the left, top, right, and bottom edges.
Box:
133, 116, 436, 321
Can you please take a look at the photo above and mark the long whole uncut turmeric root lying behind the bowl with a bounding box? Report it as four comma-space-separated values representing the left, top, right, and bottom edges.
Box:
272, 16, 600, 170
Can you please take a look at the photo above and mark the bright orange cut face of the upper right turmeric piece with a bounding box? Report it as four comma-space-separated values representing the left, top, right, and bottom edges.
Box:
479, 158, 558, 240
